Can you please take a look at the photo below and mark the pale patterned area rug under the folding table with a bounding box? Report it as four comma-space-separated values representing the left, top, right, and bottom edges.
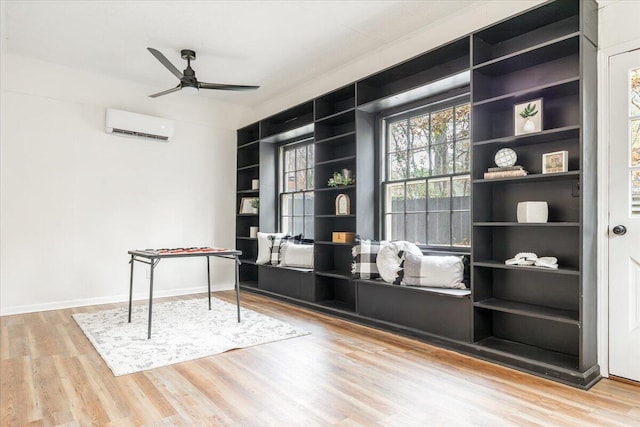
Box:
73, 298, 309, 376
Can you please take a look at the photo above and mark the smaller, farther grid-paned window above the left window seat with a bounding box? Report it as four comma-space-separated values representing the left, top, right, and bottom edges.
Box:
280, 140, 314, 239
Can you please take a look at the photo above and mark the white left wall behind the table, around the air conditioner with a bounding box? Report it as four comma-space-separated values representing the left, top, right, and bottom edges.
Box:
0, 55, 248, 314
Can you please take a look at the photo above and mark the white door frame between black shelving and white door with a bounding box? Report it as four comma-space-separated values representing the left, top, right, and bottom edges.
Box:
597, 39, 640, 377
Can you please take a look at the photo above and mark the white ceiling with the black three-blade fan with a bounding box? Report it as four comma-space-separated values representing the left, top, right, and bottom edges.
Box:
2, 0, 480, 106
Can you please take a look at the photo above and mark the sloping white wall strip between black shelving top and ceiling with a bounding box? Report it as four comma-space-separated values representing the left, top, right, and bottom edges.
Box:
244, 0, 544, 124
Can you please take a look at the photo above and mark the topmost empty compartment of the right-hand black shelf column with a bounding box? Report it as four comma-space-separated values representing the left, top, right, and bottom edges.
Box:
473, 1, 580, 65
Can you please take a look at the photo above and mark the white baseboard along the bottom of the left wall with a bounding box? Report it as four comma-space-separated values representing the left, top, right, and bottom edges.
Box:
0, 283, 234, 316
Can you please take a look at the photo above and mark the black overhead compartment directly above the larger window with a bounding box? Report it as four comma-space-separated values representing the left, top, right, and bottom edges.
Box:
357, 36, 470, 108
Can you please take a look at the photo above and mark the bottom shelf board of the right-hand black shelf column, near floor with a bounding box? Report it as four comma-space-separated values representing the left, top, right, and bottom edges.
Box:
475, 337, 578, 370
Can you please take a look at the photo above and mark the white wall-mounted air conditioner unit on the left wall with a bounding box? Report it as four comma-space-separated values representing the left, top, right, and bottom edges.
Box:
105, 108, 173, 141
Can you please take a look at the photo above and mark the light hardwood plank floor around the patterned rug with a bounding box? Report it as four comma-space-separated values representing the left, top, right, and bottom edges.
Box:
0, 292, 640, 426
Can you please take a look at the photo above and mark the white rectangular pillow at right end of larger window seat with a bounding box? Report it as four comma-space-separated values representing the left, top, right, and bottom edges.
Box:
402, 253, 466, 289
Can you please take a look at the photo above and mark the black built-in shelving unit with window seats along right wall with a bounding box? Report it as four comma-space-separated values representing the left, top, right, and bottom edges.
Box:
236, 0, 599, 388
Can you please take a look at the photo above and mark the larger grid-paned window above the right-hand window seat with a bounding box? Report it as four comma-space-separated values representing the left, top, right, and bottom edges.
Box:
381, 103, 471, 247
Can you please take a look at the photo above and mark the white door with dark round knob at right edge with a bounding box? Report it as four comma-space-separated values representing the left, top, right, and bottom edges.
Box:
609, 49, 640, 381
